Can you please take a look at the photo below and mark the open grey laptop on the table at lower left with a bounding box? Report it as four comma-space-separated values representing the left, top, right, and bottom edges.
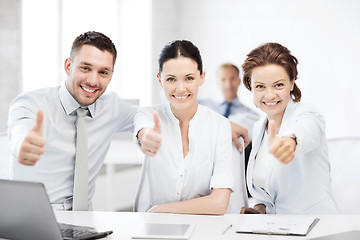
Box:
0, 179, 112, 240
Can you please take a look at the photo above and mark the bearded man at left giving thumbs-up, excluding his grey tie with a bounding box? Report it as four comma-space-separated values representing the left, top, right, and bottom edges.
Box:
8, 32, 136, 210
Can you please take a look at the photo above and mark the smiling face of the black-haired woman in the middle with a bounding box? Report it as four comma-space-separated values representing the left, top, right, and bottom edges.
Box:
158, 56, 205, 116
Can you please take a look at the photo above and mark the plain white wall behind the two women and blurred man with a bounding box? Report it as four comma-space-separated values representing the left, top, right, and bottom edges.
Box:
152, 0, 360, 137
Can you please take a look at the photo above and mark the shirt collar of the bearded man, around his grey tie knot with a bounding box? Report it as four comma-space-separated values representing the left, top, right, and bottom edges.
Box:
59, 82, 96, 118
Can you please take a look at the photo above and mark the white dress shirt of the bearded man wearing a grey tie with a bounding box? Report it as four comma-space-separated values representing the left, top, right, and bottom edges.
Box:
8, 84, 136, 209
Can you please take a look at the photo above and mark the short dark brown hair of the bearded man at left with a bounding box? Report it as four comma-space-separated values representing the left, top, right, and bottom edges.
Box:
70, 31, 117, 66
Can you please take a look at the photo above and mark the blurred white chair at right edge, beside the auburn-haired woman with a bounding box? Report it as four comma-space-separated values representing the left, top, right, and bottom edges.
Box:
328, 137, 360, 214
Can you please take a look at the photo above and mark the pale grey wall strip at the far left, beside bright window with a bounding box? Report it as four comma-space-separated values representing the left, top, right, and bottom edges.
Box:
0, 0, 21, 132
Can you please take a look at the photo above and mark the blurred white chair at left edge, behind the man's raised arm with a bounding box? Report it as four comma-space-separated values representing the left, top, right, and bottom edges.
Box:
0, 132, 10, 179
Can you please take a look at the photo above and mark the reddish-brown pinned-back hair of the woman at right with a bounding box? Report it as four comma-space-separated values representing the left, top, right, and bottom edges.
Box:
242, 43, 301, 102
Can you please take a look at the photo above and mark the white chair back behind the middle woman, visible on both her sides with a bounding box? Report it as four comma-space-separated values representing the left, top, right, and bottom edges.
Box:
134, 138, 248, 213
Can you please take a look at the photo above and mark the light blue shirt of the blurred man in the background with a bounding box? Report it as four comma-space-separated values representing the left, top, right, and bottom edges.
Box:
198, 98, 260, 139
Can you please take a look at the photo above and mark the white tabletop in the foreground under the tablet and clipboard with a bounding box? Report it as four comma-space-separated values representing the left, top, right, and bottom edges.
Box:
55, 212, 360, 240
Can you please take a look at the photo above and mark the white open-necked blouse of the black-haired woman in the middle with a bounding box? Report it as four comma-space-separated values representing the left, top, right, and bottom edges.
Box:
134, 102, 233, 211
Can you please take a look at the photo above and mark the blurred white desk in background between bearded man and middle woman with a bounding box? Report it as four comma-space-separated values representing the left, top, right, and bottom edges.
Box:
93, 132, 144, 211
